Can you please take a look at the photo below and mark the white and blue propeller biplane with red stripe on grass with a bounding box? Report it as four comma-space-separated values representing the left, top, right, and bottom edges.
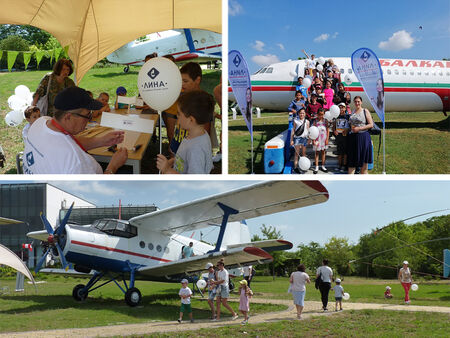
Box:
27, 181, 329, 306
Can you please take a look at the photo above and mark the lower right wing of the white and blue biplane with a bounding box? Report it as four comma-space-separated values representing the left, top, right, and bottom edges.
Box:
138, 247, 273, 279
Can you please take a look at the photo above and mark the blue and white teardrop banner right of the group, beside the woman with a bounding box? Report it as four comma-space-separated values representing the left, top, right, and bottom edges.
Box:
352, 48, 384, 126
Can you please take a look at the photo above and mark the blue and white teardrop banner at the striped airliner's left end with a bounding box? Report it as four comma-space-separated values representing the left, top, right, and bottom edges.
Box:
228, 50, 253, 138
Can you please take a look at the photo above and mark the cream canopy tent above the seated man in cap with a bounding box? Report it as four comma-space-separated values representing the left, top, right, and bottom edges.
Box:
0, 0, 222, 83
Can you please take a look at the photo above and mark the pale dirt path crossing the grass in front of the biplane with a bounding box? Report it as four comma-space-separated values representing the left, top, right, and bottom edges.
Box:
0, 299, 450, 338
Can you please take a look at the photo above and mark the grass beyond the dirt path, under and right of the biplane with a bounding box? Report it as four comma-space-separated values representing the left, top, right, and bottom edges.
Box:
0, 276, 450, 336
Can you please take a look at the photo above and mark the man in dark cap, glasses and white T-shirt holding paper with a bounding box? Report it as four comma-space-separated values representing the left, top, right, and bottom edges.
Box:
23, 87, 128, 174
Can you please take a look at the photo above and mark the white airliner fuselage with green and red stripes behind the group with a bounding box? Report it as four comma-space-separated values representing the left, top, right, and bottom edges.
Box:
228, 57, 450, 114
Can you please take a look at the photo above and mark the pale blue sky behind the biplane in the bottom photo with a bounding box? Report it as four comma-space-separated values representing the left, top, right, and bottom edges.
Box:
18, 180, 450, 246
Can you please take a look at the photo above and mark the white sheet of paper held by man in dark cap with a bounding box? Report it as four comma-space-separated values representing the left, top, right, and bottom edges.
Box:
100, 112, 154, 134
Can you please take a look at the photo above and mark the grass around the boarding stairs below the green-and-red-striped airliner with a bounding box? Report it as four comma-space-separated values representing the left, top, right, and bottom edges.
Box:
228, 112, 450, 174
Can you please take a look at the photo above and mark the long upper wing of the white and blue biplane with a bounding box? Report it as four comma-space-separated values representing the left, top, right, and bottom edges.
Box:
129, 181, 328, 235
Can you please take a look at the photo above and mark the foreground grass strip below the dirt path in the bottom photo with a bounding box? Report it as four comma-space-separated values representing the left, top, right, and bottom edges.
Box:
151, 310, 450, 337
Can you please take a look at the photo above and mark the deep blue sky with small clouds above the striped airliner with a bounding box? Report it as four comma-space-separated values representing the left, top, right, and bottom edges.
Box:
228, 0, 450, 72
